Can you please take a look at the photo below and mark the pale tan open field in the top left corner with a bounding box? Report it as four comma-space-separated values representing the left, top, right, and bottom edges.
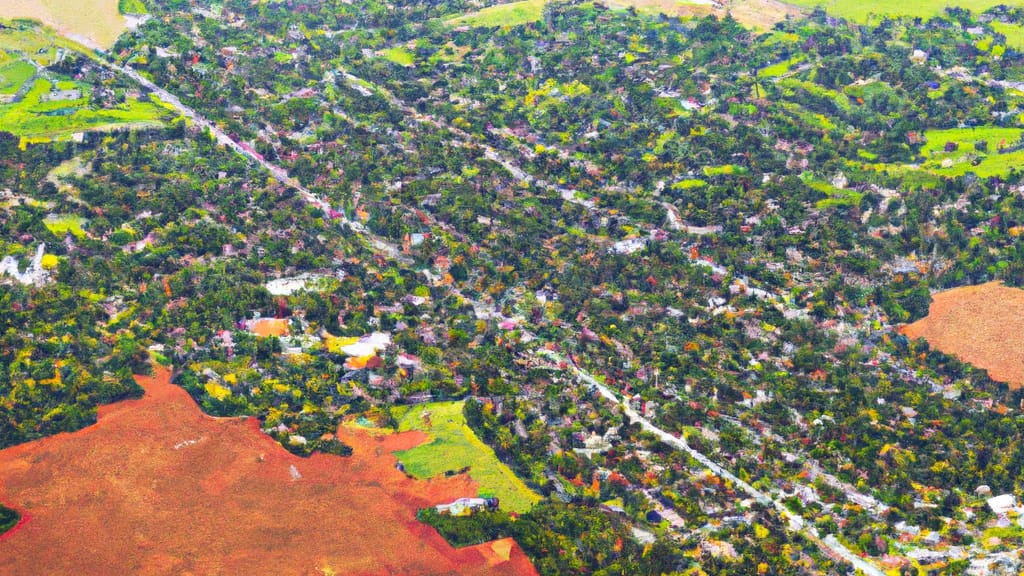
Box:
0, 0, 129, 49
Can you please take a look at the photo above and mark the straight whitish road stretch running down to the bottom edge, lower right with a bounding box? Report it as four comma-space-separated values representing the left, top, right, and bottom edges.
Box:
537, 348, 886, 576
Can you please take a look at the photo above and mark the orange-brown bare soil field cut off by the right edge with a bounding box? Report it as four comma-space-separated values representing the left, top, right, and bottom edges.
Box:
900, 282, 1024, 388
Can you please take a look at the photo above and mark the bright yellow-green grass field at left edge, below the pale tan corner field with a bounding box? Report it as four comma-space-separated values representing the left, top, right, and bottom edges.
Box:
0, 78, 167, 145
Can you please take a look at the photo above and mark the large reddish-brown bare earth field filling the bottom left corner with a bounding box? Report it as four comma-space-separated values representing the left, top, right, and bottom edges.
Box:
0, 369, 536, 576
